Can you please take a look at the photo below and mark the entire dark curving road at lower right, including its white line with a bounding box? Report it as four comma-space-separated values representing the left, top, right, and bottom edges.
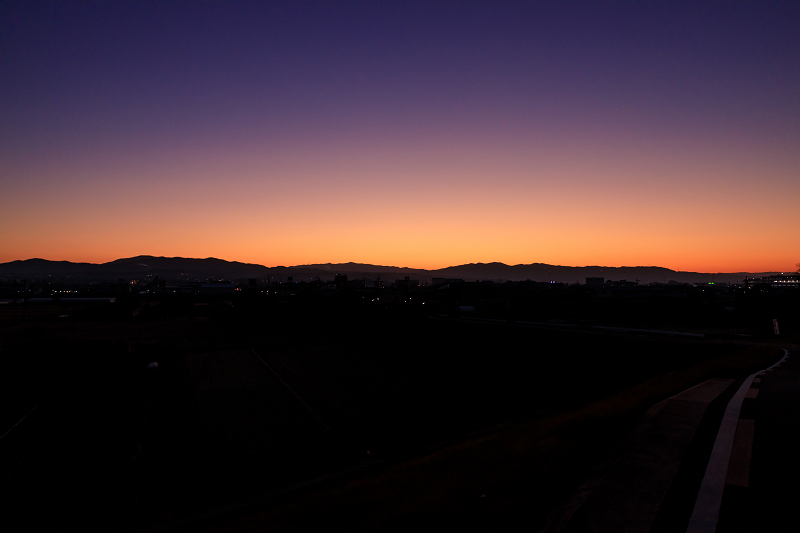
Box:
542, 347, 800, 533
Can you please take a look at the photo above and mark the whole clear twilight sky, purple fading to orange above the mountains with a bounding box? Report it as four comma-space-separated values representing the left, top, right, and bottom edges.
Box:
0, 1, 800, 272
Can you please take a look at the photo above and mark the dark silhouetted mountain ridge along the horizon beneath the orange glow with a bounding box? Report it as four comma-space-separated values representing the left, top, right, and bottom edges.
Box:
0, 255, 774, 283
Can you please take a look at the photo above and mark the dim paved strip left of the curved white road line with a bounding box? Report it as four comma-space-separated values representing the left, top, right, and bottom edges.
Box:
542, 379, 742, 533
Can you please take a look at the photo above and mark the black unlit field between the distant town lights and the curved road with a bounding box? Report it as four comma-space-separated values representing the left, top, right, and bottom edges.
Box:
0, 302, 778, 531
